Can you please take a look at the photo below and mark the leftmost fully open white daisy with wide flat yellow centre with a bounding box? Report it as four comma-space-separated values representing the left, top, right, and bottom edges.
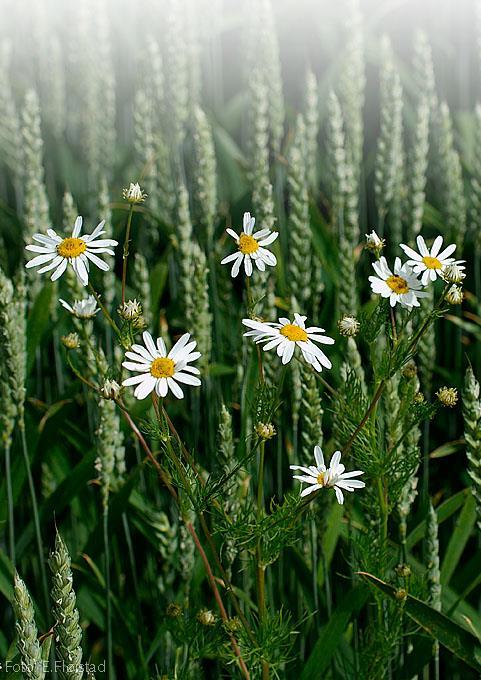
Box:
25, 216, 118, 286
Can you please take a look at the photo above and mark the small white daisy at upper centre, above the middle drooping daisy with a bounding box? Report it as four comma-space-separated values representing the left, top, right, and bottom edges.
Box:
221, 213, 279, 277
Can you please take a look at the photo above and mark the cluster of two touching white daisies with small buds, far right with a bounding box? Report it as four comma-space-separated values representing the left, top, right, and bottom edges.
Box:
368, 232, 465, 309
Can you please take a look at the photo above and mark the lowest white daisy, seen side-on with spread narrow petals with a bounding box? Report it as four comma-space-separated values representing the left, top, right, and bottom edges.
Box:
290, 446, 366, 505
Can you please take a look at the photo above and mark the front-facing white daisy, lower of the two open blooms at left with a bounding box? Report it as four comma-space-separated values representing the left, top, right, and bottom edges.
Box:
122, 331, 201, 399
